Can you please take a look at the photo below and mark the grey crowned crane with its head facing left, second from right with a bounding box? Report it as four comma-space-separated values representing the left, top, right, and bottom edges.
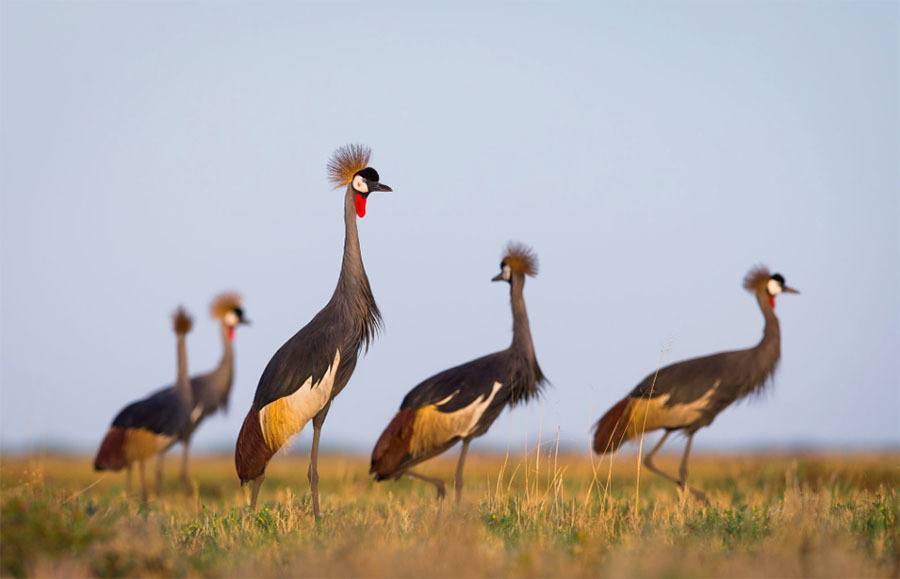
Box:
370, 243, 546, 502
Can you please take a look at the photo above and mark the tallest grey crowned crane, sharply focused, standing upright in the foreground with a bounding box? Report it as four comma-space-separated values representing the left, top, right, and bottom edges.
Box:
234, 145, 391, 519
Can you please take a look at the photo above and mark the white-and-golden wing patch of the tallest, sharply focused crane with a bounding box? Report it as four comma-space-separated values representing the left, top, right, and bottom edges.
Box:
259, 350, 341, 452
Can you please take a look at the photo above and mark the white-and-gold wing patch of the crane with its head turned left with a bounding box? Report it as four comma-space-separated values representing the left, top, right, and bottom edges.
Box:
409, 382, 503, 457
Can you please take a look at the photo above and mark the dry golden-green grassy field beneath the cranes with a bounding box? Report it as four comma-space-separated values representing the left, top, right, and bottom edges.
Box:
0, 449, 900, 577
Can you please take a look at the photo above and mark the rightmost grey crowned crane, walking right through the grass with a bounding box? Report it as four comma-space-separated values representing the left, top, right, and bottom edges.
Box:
594, 266, 800, 500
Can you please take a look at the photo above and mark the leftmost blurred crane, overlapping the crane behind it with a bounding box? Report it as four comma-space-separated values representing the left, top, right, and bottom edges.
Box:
94, 308, 193, 501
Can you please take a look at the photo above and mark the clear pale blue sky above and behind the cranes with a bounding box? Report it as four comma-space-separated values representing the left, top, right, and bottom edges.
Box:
0, 1, 900, 450
